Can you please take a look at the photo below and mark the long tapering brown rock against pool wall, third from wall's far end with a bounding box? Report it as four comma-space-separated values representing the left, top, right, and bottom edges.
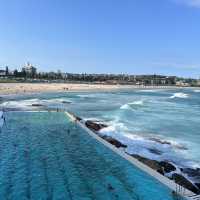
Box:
131, 154, 164, 175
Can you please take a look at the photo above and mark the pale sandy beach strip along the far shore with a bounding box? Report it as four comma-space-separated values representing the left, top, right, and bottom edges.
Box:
0, 83, 178, 94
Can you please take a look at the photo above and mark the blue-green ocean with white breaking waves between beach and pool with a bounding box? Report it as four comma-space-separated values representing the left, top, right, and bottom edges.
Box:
1, 88, 200, 168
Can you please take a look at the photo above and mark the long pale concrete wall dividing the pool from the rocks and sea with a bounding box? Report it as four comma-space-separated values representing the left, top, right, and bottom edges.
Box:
65, 111, 196, 200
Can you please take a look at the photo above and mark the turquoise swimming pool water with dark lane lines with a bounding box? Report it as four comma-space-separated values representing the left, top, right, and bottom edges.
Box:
0, 112, 173, 200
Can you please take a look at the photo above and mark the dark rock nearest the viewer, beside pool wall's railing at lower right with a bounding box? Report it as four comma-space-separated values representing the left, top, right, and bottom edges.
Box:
172, 173, 200, 194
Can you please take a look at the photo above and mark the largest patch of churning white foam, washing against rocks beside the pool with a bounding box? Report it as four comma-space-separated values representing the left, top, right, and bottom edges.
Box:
99, 122, 194, 166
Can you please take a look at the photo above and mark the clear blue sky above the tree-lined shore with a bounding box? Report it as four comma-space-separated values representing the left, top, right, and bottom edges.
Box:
0, 0, 200, 77
